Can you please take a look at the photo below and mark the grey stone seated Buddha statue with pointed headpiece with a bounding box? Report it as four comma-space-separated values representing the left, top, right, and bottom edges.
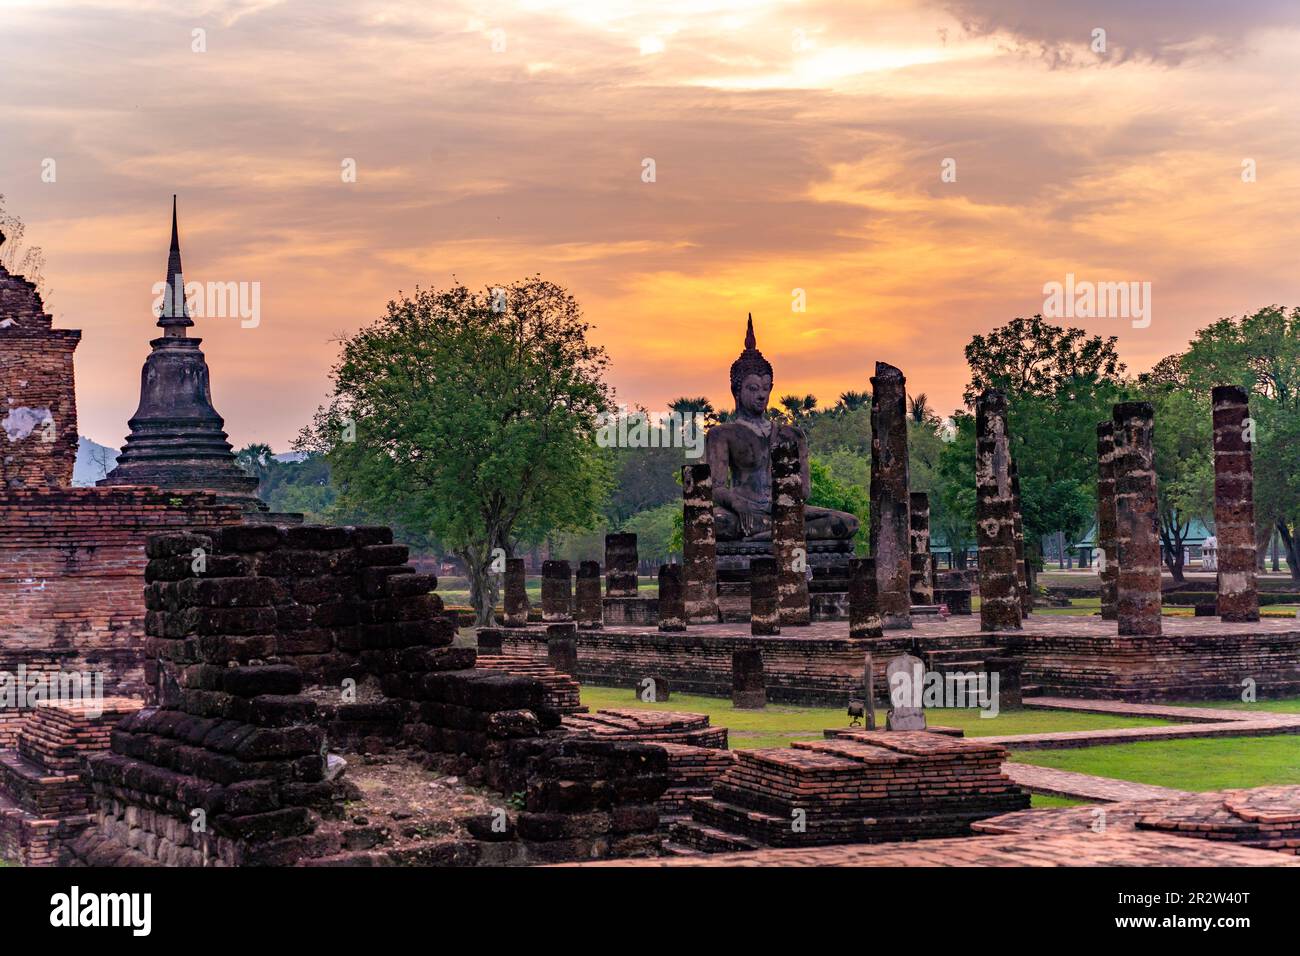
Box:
705, 316, 858, 542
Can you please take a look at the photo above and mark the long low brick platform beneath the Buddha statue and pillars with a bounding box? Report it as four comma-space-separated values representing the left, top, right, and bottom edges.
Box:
493, 615, 1300, 706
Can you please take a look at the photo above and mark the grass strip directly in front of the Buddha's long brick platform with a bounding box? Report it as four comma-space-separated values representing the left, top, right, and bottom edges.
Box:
582, 684, 1165, 749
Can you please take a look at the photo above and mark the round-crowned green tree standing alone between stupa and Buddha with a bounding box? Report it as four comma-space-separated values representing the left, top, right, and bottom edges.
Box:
298, 277, 611, 624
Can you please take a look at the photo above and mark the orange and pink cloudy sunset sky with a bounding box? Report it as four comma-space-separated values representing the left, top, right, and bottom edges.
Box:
0, 0, 1300, 450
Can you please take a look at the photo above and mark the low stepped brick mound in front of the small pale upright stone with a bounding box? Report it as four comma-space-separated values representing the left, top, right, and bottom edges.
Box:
672, 731, 1030, 851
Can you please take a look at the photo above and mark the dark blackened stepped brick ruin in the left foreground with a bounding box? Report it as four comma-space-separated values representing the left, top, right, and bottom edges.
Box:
68, 524, 671, 866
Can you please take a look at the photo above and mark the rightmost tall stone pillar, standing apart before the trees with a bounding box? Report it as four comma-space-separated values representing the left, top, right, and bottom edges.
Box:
1212, 385, 1260, 620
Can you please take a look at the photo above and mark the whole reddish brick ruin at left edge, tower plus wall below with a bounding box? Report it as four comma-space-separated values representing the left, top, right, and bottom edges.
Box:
0, 230, 242, 748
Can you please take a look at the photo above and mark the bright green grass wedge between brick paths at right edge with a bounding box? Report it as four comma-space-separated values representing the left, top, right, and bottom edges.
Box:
1011, 735, 1300, 791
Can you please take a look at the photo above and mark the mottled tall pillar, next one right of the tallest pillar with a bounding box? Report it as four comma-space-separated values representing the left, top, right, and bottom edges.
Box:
975, 389, 1021, 631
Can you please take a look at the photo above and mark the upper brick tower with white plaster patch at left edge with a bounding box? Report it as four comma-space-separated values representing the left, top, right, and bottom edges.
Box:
0, 260, 81, 490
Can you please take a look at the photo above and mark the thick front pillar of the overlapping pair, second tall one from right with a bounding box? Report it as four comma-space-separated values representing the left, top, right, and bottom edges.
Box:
1112, 402, 1161, 635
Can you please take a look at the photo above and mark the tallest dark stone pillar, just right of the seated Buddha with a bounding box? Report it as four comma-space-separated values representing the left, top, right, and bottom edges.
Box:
871, 362, 911, 630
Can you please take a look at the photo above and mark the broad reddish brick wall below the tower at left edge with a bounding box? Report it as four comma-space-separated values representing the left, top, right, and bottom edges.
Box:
0, 488, 241, 723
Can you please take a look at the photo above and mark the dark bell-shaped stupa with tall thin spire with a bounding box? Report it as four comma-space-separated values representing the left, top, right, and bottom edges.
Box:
99, 196, 267, 511
